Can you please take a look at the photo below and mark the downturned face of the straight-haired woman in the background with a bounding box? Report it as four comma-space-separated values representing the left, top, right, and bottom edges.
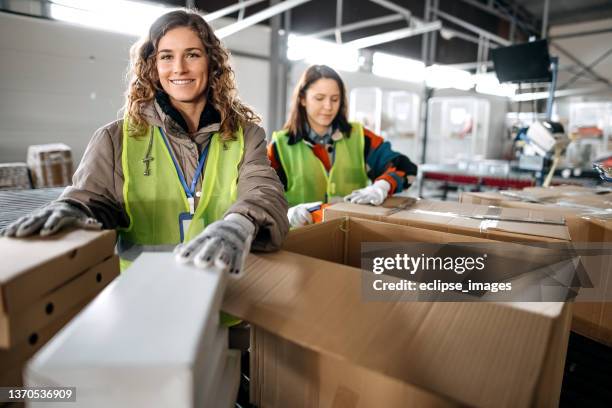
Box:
300, 78, 341, 135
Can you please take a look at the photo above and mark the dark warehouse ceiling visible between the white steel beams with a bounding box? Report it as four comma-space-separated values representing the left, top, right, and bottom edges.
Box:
153, 0, 612, 68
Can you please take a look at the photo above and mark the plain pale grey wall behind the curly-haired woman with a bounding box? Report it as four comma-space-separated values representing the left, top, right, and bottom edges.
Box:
0, 12, 269, 166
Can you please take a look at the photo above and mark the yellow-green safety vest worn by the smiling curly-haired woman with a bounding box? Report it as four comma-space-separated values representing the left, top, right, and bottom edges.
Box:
118, 119, 244, 262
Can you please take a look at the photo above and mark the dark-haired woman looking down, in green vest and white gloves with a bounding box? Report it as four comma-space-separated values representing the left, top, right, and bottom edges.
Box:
268, 65, 417, 227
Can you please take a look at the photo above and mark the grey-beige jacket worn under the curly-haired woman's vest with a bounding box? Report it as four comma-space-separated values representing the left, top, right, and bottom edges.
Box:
60, 102, 289, 251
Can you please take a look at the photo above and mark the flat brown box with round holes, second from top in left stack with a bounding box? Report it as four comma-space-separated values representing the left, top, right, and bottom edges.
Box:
0, 255, 119, 348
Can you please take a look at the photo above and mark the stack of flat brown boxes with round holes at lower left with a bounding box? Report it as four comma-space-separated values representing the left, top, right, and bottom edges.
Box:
0, 230, 119, 386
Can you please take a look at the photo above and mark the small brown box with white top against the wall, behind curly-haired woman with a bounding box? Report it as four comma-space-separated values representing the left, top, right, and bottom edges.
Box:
27, 143, 73, 188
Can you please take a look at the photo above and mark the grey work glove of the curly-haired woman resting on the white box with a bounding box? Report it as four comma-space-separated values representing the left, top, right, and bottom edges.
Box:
174, 213, 255, 275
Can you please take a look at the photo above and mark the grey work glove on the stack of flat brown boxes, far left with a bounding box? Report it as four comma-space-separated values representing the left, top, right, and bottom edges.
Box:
2, 201, 102, 238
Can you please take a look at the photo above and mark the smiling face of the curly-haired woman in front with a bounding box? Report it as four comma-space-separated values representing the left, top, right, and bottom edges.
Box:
155, 27, 208, 108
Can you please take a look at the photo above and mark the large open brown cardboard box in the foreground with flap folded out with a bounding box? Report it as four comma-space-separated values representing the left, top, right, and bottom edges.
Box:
223, 215, 571, 407
